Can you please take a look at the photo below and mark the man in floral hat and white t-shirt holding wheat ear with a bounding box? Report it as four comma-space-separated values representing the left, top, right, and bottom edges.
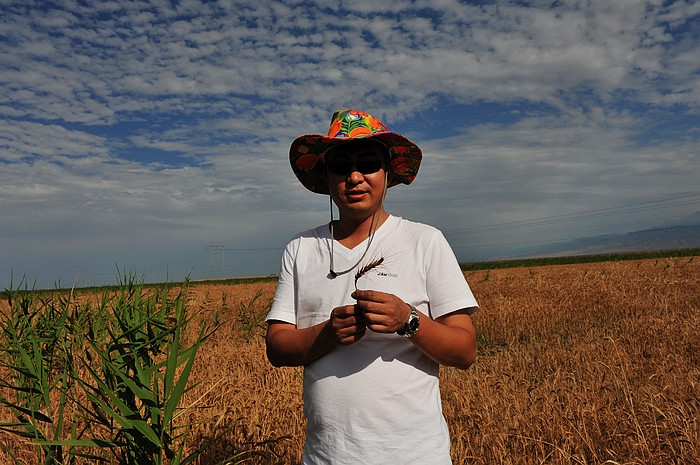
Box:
266, 110, 478, 465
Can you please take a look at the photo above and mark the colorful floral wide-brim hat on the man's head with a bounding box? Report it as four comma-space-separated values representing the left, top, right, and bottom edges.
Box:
289, 109, 423, 194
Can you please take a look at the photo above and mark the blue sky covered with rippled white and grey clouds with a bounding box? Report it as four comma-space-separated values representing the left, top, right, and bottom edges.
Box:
0, 0, 700, 287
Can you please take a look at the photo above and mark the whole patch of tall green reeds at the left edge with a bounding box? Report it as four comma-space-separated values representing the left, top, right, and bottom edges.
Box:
0, 276, 238, 465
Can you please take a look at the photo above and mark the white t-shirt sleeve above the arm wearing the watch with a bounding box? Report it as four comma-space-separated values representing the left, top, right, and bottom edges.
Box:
426, 230, 479, 319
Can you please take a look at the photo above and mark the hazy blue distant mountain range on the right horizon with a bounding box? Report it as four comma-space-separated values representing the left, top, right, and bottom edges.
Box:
527, 212, 700, 257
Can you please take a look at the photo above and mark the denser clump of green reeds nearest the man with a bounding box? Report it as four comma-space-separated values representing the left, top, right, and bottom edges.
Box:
74, 280, 209, 464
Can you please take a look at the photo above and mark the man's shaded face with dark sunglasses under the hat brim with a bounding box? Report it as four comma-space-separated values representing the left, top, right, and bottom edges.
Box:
325, 141, 386, 217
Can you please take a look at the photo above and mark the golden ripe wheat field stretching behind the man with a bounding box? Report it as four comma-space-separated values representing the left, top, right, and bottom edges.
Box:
0, 257, 700, 465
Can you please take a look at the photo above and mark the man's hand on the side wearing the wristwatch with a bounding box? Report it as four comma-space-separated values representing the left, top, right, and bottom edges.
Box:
351, 290, 411, 333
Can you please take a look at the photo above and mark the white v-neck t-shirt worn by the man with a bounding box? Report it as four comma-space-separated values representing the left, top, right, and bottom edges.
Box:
267, 216, 477, 465
